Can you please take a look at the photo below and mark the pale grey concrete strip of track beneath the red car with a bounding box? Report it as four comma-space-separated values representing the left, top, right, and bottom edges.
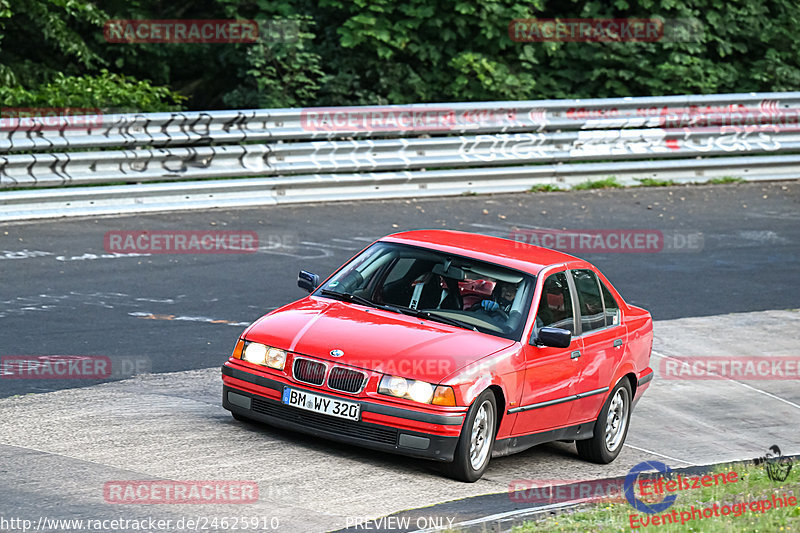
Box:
0, 310, 800, 533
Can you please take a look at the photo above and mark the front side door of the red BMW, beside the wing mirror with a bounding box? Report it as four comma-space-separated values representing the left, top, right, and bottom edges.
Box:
509, 271, 582, 435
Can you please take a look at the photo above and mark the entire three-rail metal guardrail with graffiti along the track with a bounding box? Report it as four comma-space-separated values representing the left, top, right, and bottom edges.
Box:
0, 92, 800, 220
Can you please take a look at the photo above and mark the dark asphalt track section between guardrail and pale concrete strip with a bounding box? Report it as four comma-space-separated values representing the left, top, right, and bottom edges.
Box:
0, 182, 800, 397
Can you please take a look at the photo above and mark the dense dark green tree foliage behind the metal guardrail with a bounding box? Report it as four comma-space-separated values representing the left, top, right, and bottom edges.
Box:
0, 0, 800, 111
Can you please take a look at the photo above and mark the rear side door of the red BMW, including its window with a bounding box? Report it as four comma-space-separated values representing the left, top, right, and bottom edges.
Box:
569, 268, 627, 423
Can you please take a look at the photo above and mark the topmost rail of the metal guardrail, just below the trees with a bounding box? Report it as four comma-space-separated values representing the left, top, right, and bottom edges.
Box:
0, 92, 800, 153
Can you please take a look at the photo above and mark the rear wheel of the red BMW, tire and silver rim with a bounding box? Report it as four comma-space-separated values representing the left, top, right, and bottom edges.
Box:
575, 378, 631, 464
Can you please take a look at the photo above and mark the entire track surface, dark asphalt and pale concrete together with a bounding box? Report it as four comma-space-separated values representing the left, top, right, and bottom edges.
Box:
0, 182, 800, 531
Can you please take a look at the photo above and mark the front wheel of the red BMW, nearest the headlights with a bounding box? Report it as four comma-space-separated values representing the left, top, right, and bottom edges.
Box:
444, 390, 497, 483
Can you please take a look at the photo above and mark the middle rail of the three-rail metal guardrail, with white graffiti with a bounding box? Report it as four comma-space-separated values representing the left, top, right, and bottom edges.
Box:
0, 130, 800, 187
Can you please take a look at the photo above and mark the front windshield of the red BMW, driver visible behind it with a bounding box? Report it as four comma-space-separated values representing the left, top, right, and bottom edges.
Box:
315, 242, 535, 340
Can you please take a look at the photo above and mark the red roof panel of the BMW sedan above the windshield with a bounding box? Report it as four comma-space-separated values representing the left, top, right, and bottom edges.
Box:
380, 230, 579, 275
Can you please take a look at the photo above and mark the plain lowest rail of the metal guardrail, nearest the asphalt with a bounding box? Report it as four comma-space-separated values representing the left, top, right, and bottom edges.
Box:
0, 155, 800, 221
